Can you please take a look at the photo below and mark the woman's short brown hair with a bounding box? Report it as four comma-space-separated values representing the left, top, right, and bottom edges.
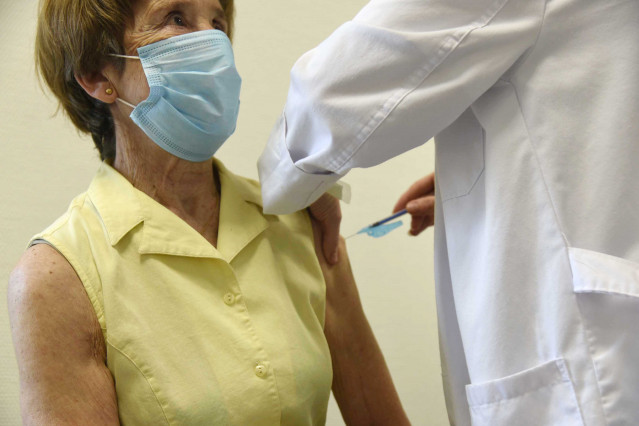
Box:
35, 0, 235, 160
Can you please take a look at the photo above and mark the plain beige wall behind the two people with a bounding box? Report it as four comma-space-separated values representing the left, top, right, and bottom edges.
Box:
0, 0, 447, 425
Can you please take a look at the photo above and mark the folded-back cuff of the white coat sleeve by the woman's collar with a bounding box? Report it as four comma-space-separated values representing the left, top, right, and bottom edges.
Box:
257, 115, 341, 214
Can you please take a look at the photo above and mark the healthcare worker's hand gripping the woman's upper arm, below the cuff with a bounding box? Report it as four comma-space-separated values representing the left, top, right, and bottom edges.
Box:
308, 194, 342, 265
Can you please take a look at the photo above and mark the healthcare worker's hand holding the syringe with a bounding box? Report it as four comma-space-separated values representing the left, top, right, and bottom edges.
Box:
393, 173, 435, 236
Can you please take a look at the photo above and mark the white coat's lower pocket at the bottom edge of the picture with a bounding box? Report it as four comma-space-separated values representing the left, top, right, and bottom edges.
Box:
466, 358, 584, 426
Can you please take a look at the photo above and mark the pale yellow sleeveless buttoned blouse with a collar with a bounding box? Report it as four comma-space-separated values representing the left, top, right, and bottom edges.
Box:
32, 161, 332, 425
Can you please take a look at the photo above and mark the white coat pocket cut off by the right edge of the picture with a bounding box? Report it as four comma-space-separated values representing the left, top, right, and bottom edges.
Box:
568, 248, 639, 425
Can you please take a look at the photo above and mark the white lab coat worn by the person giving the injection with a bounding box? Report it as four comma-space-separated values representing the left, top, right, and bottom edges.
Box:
259, 0, 639, 426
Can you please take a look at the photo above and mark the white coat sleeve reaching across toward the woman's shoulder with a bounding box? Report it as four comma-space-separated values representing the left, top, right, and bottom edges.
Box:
258, 0, 545, 213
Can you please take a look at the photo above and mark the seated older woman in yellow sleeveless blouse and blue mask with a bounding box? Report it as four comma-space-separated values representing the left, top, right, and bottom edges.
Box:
9, 0, 407, 425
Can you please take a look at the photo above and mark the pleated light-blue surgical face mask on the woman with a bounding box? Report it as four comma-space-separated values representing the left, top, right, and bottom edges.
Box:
112, 30, 242, 162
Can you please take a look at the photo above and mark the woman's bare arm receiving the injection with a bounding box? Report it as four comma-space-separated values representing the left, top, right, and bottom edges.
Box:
314, 221, 410, 425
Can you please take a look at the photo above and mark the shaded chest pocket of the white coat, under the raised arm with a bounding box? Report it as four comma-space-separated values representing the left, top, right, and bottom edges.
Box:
435, 108, 485, 202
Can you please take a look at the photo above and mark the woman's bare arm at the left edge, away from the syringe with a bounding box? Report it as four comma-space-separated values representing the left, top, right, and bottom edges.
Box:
8, 244, 119, 425
